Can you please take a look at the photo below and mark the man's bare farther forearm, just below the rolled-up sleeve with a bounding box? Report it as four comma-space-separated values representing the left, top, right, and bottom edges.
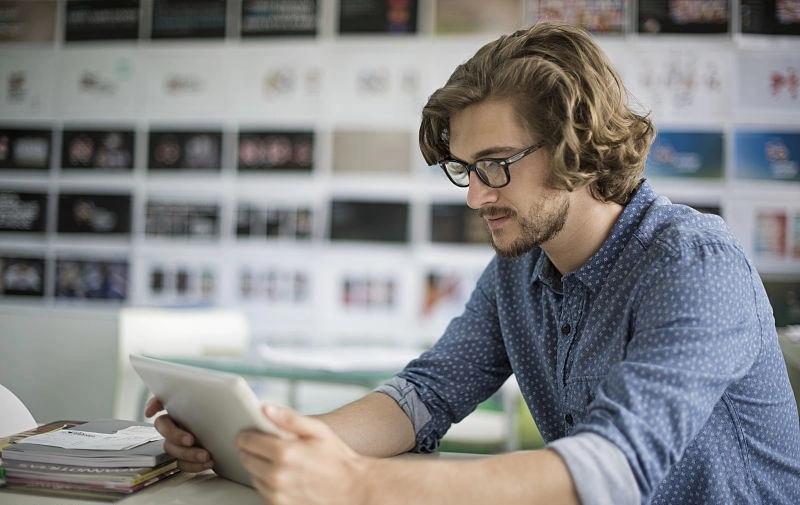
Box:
315, 393, 415, 457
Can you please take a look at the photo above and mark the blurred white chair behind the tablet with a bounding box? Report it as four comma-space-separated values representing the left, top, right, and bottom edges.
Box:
114, 307, 250, 420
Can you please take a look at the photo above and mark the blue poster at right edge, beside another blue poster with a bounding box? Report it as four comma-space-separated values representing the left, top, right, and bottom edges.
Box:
734, 131, 800, 182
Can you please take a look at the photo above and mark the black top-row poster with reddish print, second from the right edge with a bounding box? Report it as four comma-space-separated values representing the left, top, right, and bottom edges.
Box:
638, 0, 730, 34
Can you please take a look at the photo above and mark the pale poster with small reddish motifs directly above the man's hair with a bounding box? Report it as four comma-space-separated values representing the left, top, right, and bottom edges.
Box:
528, 0, 628, 33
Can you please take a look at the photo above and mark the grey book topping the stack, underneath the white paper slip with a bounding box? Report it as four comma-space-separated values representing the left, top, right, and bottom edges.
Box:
0, 419, 174, 468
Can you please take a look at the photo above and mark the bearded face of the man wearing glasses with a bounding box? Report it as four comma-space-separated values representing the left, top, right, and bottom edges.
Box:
450, 100, 570, 257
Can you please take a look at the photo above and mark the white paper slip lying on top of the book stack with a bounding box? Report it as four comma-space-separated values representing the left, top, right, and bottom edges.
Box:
20, 426, 163, 451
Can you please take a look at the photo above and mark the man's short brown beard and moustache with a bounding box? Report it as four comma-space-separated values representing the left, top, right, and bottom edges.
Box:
480, 194, 569, 258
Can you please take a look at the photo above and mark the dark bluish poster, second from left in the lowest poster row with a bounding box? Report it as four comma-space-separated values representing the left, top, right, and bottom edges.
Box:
54, 258, 128, 301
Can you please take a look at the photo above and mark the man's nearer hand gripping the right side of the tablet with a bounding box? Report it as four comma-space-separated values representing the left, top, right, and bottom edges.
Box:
236, 405, 370, 505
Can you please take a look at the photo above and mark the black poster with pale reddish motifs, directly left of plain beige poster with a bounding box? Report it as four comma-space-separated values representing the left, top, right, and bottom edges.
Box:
236, 131, 314, 172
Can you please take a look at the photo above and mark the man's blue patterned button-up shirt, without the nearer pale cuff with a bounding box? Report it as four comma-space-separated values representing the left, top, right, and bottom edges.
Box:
379, 181, 800, 505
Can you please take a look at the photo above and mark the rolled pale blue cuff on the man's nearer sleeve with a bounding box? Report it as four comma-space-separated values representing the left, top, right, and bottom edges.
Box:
547, 432, 642, 505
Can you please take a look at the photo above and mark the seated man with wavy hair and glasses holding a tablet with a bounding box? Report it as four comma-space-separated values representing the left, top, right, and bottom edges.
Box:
146, 23, 800, 505
